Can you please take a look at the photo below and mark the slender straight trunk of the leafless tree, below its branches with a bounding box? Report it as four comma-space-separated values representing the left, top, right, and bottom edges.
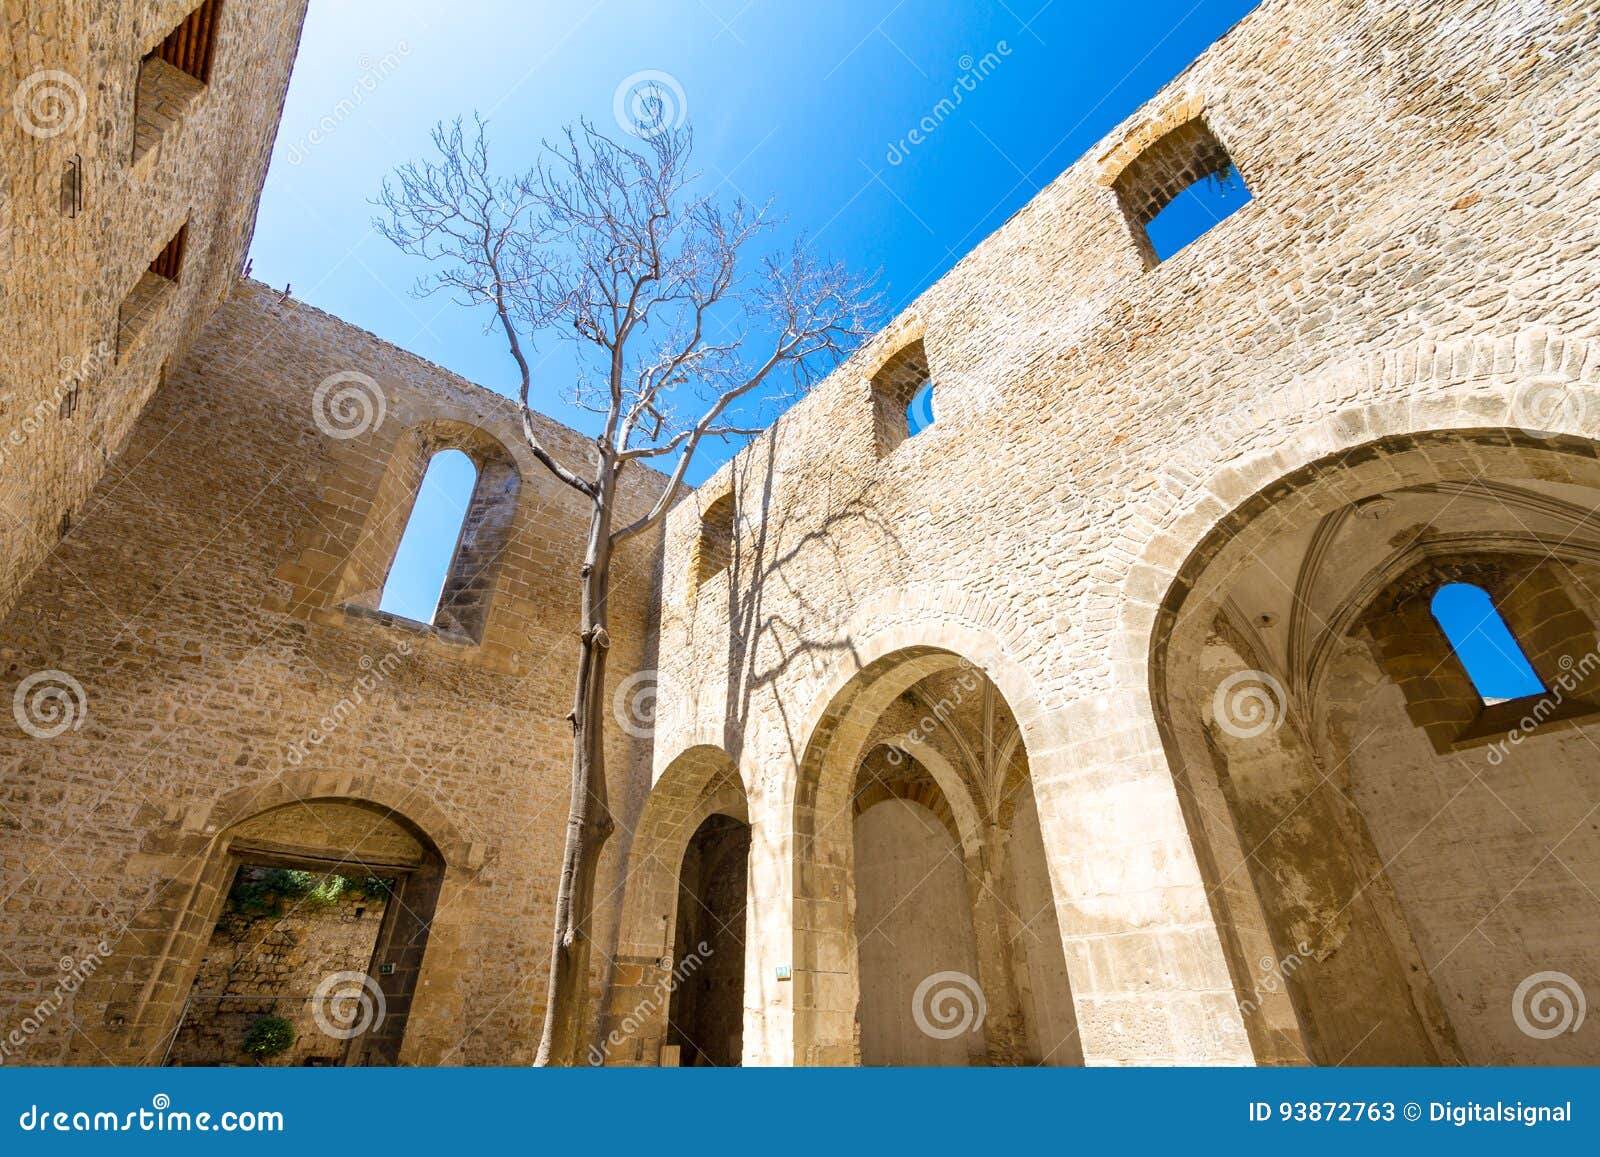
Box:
534, 483, 613, 1066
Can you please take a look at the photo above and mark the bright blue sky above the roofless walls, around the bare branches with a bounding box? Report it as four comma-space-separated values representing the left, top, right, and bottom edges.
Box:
251, 0, 1253, 618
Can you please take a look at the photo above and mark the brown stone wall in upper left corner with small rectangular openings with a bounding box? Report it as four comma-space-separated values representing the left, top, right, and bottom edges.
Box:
0, 0, 306, 615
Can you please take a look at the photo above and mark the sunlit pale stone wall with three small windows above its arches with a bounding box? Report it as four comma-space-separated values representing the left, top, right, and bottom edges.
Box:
654, 0, 1600, 1064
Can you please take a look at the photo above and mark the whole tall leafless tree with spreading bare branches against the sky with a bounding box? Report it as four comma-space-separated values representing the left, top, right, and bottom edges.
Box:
374, 108, 877, 1064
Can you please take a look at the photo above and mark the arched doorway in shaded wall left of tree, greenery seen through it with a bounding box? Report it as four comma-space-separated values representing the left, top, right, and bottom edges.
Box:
85, 796, 461, 1066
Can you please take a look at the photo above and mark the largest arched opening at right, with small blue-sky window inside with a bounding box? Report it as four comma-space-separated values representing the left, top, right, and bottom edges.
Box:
1150, 430, 1600, 1064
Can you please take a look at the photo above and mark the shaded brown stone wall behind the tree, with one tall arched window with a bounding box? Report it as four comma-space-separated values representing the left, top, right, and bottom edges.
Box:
0, 282, 664, 1064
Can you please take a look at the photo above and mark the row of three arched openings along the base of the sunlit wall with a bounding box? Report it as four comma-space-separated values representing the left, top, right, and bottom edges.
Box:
611, 430, 1600, 1066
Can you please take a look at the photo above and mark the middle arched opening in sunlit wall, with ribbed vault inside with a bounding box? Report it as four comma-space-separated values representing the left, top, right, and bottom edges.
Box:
794, 648, 1082, 1064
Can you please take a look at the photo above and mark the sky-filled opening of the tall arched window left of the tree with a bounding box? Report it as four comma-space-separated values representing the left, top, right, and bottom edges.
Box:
378, 450, 478, 623
